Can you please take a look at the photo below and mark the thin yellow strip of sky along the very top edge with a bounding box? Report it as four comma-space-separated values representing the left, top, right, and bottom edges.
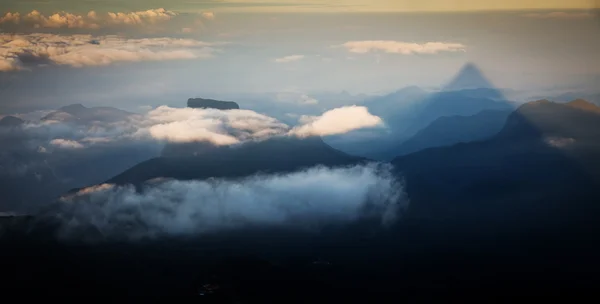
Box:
3, 0, 595, 12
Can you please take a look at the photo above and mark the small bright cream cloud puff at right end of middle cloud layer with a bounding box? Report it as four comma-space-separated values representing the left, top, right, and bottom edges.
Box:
290, 106, 383, 137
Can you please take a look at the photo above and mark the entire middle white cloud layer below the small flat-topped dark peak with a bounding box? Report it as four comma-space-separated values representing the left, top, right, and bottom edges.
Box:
19, 106, 383, 149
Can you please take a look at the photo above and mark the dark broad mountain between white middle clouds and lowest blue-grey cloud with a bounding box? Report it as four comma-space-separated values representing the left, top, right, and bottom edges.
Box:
107, 136, 364, 185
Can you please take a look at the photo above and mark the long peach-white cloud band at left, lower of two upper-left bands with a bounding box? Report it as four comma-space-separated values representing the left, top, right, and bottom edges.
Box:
0, 34, 215, 71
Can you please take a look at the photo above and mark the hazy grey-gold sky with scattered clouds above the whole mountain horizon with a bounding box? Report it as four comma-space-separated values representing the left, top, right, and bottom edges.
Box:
0, 0, 600, 113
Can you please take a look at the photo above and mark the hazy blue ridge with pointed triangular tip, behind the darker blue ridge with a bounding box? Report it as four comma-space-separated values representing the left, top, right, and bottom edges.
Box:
325, 63, 515, 160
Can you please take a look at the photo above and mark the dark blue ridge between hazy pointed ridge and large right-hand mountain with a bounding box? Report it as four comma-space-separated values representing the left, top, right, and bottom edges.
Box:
387, 110, 510, 156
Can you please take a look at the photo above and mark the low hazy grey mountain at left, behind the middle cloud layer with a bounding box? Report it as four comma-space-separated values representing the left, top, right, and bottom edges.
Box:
42, 104, 134, 123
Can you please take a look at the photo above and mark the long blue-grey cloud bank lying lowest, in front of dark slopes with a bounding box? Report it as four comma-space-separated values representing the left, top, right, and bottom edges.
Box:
47, 164, 408, 239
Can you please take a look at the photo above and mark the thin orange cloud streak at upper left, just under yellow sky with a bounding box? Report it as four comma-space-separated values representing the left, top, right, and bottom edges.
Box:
0, 8, 178, 29
